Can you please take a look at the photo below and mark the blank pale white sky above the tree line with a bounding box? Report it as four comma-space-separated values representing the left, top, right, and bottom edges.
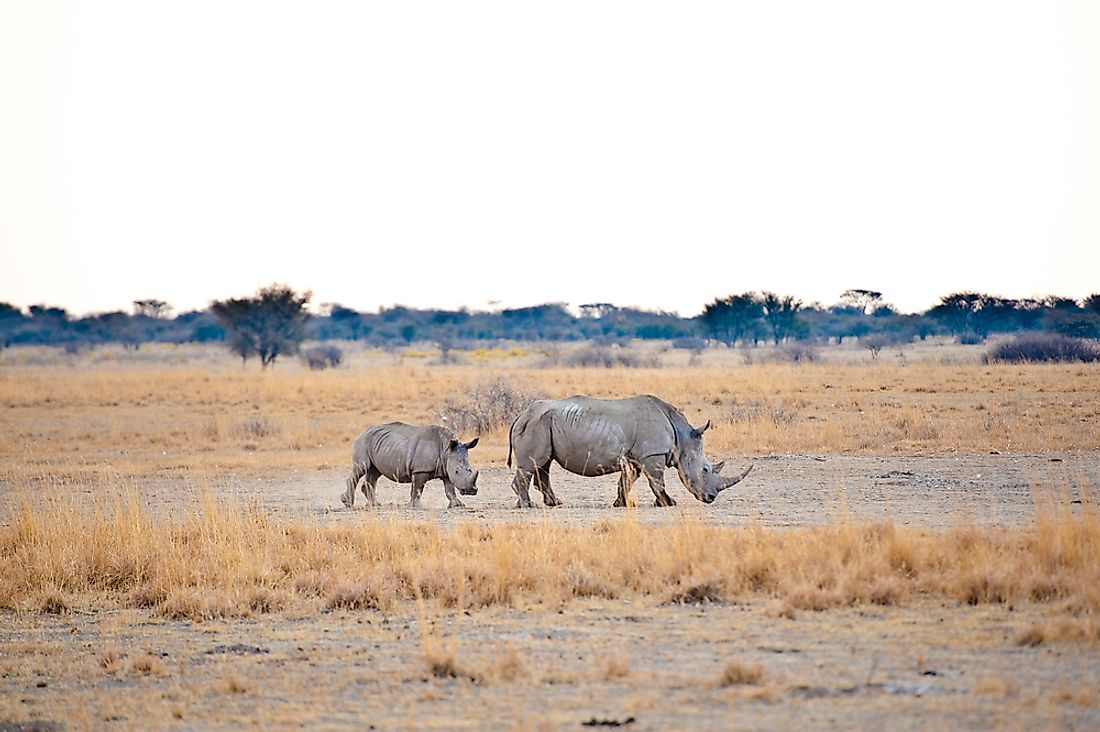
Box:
0, 0, 1100, 315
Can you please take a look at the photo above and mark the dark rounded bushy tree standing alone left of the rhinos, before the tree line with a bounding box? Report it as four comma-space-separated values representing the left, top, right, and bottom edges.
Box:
210, 284, 312, 369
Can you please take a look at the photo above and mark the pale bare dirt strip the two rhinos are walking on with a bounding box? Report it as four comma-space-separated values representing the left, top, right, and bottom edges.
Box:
47, 451, 1100, 527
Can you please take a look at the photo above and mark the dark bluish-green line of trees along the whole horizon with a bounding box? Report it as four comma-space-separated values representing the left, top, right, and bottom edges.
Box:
0, 285, 1100, 365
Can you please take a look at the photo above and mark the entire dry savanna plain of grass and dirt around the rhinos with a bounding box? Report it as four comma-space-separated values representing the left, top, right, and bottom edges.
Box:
0, 343, 1100, 729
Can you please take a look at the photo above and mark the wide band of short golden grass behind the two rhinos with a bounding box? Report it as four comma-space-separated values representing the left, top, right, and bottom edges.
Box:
0, 362, 1100, 479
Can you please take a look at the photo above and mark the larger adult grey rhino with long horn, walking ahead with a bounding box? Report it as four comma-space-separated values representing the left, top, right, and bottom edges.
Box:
508, 394, 752, 507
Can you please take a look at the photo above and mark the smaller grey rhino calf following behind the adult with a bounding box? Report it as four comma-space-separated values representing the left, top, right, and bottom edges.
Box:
340, 422, 477, 509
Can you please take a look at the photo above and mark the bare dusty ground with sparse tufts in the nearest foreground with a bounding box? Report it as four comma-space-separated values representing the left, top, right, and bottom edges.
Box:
0, 601, 1100, 730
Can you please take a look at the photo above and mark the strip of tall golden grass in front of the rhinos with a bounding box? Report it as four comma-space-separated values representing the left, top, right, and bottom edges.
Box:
0, 492, 1100, 642
